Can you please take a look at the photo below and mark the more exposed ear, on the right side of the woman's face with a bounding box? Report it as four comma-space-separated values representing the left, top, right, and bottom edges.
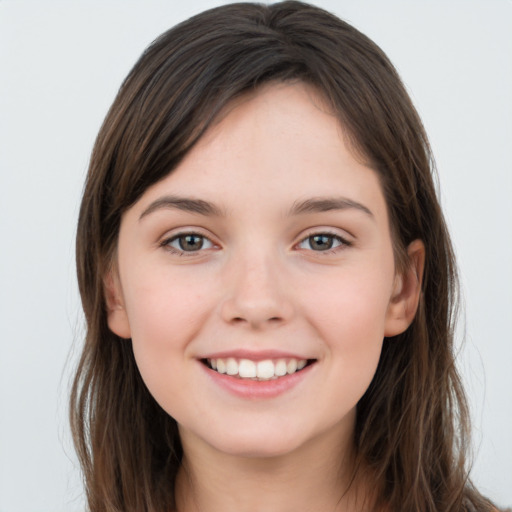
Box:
384, 240, 425, 337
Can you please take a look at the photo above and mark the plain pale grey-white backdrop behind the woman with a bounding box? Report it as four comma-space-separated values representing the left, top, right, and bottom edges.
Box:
0, 0, 512, 512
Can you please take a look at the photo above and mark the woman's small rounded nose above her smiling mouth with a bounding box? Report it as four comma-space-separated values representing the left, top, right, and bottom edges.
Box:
221, 250, 294, 330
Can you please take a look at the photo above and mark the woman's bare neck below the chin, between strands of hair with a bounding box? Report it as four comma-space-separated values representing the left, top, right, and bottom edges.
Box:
176, 422, 369, 512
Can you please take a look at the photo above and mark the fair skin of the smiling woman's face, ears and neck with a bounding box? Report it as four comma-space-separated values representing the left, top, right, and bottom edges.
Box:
105, 83, 424, 512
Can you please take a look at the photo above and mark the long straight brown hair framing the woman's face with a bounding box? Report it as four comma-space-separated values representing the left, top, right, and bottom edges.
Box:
70, 2, 496, 512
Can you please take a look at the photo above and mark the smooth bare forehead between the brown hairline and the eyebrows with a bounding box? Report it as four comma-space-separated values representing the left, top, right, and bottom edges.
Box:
129, 82, 383, 223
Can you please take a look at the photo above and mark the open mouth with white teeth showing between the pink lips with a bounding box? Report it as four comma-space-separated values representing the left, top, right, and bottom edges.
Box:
202, 357, 316, 381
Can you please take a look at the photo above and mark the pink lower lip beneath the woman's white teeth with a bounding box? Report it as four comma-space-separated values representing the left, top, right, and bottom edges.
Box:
201, 363, 315, 400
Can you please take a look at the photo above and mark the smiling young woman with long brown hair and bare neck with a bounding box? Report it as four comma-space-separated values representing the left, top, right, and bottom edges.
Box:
71, 2, 504, 512
